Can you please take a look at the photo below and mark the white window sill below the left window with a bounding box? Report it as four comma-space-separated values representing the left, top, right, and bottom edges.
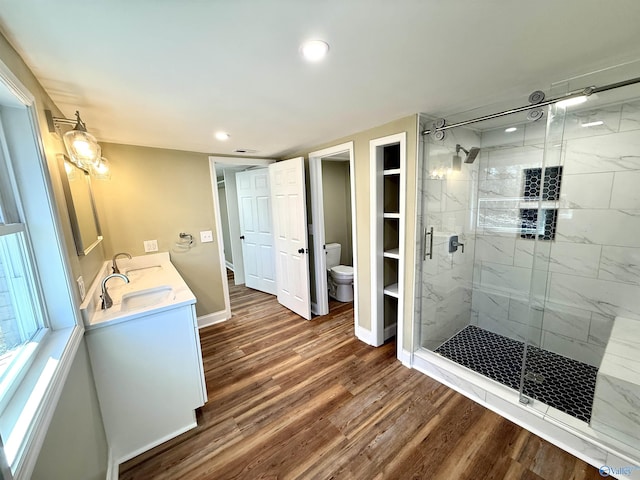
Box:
0, 326, 84, 480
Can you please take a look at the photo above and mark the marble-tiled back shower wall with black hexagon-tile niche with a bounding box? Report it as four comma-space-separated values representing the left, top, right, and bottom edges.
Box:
472, 102, 640, 366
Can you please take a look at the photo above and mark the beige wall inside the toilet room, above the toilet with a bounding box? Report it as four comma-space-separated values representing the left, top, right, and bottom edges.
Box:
322, 160, 353, 265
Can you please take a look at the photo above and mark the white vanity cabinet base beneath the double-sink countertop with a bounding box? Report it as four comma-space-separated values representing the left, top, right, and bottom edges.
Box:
85, 255, 207, 463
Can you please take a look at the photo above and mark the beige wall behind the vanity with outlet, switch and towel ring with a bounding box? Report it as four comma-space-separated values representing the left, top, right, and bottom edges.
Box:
94, 143, 224, 316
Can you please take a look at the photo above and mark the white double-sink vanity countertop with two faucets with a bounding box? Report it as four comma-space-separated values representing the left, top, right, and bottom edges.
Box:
80, 252, 196, 331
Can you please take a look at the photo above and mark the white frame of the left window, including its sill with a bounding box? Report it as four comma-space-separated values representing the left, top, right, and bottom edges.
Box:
0, 60, 84, 480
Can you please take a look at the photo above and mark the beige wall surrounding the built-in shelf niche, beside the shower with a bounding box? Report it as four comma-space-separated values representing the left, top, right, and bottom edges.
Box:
287, 115, 418, 351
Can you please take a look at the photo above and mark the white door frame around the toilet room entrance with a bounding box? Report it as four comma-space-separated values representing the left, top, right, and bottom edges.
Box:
309, 142, 360, 327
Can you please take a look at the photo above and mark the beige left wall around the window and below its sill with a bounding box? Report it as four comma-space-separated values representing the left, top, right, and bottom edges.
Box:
0, 35, 107, 479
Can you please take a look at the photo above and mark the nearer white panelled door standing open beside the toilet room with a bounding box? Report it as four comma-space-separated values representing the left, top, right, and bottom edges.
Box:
269, 157, 311, 320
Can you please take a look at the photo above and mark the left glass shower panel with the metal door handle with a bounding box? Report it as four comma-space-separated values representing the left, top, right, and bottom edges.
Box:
418, 104, 553, 398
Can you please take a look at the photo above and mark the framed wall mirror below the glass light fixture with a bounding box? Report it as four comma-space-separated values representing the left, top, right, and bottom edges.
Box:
58, 154, 102, 256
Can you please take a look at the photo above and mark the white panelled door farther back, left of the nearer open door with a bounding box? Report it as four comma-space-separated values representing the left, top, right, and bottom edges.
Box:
236, 168, 276, 295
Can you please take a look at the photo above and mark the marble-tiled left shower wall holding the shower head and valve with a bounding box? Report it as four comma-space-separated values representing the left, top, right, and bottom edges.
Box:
416, 124, 480, 349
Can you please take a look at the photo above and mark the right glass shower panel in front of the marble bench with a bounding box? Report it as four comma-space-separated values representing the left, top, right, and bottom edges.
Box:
521, 65, 640, 432
